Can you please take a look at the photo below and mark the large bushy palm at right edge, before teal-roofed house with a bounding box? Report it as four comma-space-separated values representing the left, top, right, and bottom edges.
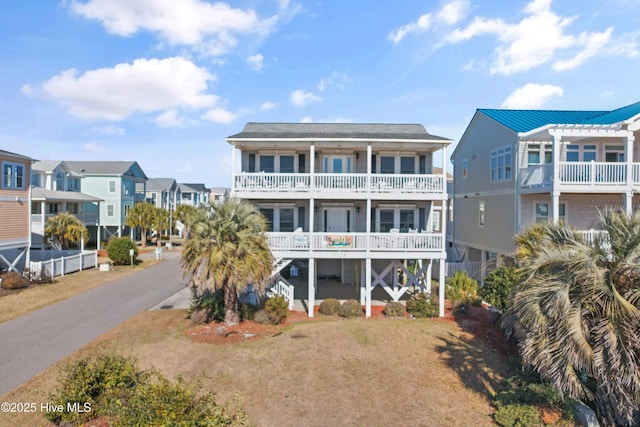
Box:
503, 212, 640, 426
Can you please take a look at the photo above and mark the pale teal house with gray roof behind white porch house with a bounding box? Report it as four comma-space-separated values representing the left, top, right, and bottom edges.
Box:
65, 161, 147, 242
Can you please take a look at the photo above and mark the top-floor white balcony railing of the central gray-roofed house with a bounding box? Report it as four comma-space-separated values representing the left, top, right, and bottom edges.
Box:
232, 172, 446, 200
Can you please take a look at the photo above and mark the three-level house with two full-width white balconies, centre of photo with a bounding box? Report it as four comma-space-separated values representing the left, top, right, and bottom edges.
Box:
227, 123, 451, 316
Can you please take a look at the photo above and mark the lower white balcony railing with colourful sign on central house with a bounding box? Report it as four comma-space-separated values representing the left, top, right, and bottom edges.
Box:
266, 232, 444, 252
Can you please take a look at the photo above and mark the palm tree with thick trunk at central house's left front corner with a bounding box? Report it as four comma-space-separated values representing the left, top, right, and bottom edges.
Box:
182, 199, 273, 326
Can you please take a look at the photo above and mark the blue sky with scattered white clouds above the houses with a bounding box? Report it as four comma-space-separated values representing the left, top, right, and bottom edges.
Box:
0, 0, 640, 186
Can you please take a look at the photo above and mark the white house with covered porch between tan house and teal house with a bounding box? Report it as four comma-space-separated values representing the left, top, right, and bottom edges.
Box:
31, 160, 102, 248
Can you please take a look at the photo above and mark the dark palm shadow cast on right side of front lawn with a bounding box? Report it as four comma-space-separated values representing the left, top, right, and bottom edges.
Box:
436, 307, 520, 400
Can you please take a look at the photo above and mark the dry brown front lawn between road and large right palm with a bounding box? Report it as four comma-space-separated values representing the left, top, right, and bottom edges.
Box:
0, 311, 508, 426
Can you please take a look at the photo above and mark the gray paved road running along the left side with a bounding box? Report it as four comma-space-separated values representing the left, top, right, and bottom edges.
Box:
0, 253, 185, 394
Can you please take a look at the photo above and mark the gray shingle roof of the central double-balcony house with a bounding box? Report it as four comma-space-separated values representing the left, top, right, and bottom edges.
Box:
227, 122, 449, 142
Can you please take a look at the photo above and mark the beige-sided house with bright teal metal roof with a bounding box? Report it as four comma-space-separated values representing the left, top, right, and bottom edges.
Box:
451, 103, 640, 272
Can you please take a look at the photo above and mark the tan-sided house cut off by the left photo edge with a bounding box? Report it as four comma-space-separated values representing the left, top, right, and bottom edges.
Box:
0, 150, 33, 270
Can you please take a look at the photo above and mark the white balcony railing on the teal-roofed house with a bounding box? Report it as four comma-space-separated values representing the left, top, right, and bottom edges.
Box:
520, 161, 640, 193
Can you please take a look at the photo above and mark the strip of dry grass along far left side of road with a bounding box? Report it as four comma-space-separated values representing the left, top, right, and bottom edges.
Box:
0, 260, 157, 323
